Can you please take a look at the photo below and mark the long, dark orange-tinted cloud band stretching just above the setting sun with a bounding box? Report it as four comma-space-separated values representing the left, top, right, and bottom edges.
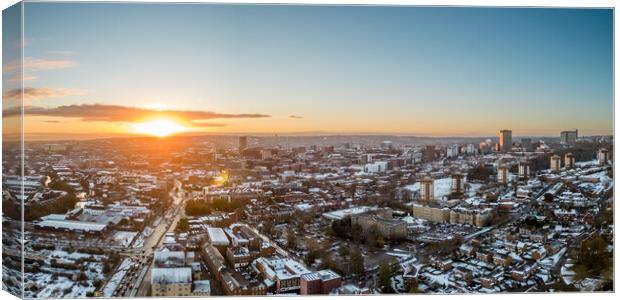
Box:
3, 104, 271, 127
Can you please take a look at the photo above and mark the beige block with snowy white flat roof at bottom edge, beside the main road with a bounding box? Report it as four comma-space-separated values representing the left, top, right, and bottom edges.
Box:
151, 267, 192, 297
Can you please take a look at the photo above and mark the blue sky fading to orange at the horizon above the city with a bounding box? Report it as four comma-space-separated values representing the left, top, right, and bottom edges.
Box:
3, 3, 613, 136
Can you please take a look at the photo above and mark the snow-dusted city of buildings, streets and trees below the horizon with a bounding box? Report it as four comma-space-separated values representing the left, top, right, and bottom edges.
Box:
2, 130, 614, 298
